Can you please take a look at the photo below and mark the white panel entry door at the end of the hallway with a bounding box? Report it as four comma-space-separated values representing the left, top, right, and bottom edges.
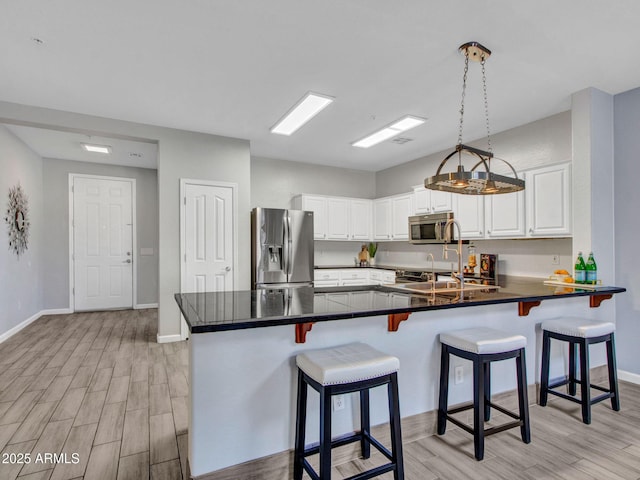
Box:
73, 177, 133, 311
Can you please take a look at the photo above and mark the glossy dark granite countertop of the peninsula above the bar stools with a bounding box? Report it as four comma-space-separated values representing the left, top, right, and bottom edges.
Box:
175, 276, 626, 334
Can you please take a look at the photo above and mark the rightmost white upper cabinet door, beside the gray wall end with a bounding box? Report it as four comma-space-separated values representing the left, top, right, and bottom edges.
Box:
525, 164, 571, 237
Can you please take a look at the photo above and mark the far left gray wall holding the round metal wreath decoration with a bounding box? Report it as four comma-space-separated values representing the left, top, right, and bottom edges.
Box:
0, 125, 44, 336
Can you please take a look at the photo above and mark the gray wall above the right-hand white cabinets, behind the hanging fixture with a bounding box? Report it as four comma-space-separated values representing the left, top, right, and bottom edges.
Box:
376, 112, 571, 197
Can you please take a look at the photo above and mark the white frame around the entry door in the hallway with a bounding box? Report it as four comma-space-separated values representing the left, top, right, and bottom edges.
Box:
69, 173, 138, 312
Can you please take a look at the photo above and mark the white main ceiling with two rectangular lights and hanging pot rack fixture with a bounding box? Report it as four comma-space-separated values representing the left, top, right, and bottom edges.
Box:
0, 0, 640, 171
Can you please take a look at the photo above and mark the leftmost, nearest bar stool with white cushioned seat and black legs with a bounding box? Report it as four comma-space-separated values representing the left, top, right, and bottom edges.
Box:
293, 343, 404, 480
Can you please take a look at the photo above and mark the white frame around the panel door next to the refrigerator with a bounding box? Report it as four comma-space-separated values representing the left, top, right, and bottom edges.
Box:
179, 178, 239, 340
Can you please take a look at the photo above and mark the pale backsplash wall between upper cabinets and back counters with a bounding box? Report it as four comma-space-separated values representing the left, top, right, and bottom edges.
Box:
315, 238, 573, 277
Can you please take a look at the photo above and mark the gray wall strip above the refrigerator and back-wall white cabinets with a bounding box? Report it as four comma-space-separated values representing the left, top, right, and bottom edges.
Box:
251, 157, 376, 208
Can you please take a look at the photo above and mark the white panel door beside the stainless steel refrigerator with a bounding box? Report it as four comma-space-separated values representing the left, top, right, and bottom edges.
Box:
182, 183, 234, 293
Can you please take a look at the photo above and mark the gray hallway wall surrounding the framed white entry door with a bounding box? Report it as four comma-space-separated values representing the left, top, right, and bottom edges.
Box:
43, 159, 158, 309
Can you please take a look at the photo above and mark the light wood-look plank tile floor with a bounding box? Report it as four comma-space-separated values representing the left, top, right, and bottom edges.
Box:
0, 310, 640, 480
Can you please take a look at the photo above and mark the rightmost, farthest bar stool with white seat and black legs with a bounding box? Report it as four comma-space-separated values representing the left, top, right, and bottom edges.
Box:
540, 317, 620, 425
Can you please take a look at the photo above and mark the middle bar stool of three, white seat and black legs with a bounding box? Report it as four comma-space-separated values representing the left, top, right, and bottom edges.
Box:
438, 327, 531, 460
